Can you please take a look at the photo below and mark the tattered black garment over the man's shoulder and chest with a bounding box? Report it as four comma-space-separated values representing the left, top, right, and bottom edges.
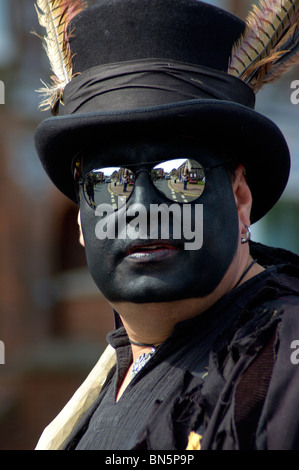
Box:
65, 243, 299, 450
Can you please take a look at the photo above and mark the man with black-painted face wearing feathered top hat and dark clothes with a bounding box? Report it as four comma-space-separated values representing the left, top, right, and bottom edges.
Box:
36, 0, 299, 450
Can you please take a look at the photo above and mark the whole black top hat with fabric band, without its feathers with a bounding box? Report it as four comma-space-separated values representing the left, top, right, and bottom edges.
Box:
35, 0, 290, 222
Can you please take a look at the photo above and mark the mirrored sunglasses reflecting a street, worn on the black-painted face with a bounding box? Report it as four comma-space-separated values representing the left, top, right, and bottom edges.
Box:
74, 158, 225, 210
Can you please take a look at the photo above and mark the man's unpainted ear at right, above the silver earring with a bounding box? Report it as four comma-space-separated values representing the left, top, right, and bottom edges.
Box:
233, 164, 252, 226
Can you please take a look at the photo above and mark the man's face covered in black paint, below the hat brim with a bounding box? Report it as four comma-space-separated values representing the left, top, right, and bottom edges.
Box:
80, 140, 238, 303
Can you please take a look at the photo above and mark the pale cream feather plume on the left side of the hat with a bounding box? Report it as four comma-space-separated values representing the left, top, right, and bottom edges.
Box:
35, 0, 86, 114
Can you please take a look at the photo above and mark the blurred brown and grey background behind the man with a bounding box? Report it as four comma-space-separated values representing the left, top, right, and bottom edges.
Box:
0, 0, 299, 450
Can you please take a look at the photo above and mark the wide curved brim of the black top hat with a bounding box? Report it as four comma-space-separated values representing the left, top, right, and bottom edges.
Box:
35, 99, 290, 223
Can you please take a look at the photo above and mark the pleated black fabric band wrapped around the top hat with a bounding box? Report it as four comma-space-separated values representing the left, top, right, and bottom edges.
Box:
59, 59, 255, 115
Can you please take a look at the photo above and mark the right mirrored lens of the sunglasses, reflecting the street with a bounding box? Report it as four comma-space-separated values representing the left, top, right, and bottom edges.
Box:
152, 158, 205, 203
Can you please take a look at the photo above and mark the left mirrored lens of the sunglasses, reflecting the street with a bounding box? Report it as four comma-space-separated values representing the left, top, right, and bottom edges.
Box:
83, 167, 135, 209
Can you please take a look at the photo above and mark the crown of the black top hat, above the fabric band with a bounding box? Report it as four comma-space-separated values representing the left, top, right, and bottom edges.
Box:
70, 0, 245, 73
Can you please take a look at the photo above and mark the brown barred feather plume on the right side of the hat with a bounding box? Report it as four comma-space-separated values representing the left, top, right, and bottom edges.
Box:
228, 0, 299, 93
